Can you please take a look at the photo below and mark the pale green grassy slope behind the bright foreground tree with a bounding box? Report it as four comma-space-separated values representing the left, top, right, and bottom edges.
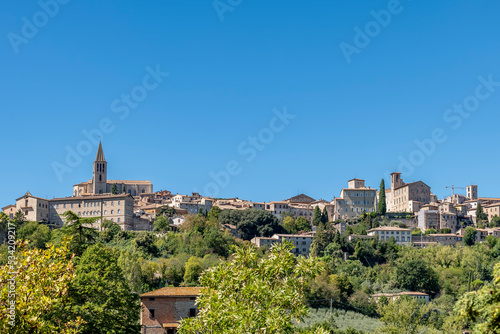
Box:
301, 308, 381, 333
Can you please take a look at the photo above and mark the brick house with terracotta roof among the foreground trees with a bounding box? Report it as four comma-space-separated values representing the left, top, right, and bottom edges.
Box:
140, 287, 202, 334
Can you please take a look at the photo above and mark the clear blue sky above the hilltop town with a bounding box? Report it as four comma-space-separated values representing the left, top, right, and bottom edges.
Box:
0, 0, 500, 206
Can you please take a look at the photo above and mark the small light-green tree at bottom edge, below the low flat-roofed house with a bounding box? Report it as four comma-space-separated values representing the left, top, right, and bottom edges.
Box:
377, 296, 430, 334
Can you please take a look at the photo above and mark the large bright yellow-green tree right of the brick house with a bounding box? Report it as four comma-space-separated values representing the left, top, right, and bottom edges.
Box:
178, 243, 321, 334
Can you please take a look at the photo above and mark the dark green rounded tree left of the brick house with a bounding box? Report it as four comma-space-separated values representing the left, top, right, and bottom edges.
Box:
70, 244, 140, 334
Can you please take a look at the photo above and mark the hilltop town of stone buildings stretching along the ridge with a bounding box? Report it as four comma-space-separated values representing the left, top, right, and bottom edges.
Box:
2, 143, 500, 249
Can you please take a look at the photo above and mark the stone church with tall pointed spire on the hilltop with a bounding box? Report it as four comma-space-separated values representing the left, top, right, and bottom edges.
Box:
73, 142, 153, 196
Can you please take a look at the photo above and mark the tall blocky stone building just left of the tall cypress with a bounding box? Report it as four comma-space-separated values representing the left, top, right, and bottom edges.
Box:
332, 179, 377, 220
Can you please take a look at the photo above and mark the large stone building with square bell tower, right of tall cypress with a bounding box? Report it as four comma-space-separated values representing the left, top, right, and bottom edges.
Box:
385, 172, 431, 213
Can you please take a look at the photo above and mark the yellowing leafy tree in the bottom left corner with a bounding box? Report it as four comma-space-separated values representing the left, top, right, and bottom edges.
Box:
0, 239, 82, 333
